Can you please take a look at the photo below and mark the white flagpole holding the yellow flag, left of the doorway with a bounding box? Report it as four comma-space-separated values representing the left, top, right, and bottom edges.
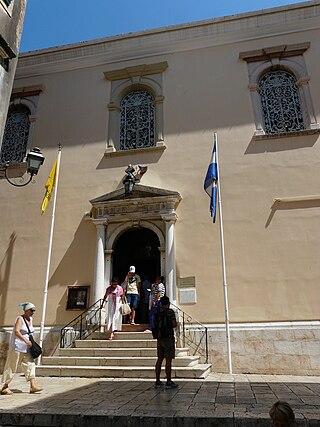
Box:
37, 143, 61, 365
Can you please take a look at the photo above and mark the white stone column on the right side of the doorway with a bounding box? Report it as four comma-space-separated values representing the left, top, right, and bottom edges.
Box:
162, 214, 177, 304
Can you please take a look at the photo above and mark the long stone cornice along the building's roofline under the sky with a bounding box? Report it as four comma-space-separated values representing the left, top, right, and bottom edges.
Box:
16, 1, 320, 78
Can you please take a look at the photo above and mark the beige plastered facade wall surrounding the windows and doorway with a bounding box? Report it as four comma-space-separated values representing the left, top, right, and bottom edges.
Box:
0, 2, 320, 336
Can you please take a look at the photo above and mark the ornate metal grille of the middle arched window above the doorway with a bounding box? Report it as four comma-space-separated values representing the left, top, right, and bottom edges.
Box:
120, 90, 154, 150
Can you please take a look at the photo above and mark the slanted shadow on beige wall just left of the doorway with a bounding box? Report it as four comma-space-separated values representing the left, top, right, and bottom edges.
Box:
49, 218, 96, 325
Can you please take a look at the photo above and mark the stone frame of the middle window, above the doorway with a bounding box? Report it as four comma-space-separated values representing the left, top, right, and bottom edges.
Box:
104, 62, 168, 156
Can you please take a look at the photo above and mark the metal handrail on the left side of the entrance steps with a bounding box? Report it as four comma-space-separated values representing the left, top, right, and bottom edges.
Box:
60, 299, 102, 348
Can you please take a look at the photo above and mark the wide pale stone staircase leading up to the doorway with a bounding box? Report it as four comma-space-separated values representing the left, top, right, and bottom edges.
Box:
36, 325, 211, 378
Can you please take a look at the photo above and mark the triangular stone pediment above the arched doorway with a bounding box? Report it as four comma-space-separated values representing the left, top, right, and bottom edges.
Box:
90, 184, 182, 221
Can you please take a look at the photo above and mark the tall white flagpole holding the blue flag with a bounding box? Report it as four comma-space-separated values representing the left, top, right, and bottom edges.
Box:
214, 132, 232, 374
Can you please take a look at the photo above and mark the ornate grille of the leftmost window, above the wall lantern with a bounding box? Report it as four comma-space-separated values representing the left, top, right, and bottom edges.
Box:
0, 105, 30, 164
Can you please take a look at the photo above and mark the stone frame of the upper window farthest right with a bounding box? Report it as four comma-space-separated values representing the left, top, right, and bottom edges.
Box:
239, 42, 320, 138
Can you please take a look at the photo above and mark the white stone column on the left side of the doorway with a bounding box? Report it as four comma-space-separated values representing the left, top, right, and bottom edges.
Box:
93, 220, 106, 303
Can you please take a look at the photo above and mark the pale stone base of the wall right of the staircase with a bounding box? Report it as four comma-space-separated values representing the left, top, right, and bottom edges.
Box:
209, 325, 320, 375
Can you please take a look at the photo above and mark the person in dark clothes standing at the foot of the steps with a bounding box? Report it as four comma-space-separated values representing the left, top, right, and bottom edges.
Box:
152, 296, 178, 389
